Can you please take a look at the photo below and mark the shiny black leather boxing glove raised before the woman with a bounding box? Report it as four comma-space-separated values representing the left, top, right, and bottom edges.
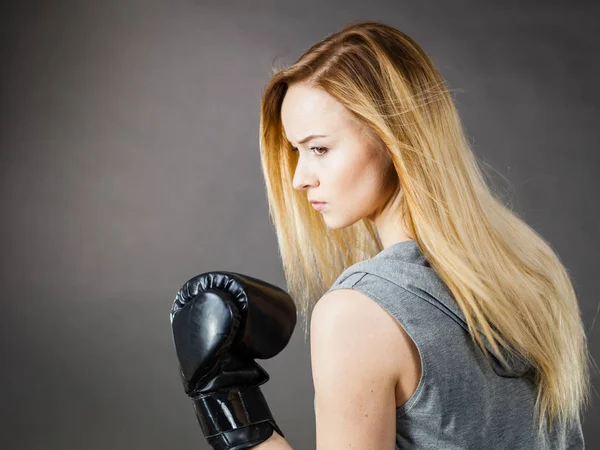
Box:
170, 272, 296, 450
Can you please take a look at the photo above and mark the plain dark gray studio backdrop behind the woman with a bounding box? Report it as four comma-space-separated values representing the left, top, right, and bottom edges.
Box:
0, 0, 600, 450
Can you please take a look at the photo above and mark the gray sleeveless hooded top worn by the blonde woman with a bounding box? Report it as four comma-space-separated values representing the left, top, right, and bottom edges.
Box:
318, 240, 585, 450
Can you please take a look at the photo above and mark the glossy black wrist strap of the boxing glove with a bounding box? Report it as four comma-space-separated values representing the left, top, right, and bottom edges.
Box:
192, 386, 285, 450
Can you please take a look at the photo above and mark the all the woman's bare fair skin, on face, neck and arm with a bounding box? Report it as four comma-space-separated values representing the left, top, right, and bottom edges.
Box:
255, 83, 421, 450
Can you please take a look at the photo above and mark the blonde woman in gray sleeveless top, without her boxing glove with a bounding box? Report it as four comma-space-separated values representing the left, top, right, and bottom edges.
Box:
257, 22, 590, 450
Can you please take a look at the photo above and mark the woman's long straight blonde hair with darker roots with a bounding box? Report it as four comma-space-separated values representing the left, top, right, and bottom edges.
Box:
255, 21, 592, 432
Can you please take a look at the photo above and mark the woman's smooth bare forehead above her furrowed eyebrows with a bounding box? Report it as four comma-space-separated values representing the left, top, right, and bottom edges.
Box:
281, 83, 351, 142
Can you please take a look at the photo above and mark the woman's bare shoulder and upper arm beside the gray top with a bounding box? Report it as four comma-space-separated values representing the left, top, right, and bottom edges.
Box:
310, 288, 412, 449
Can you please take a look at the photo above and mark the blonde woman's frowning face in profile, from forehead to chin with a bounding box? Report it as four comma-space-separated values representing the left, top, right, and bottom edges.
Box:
281, 83, 397, 229
